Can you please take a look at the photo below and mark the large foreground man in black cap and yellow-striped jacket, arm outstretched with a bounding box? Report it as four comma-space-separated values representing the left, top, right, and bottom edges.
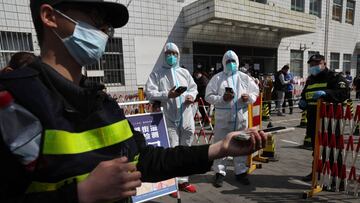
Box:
0, 0, 266, 203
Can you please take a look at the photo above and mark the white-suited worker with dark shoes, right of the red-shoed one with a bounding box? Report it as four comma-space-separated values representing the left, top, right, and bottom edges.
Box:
205, 50, 259, 187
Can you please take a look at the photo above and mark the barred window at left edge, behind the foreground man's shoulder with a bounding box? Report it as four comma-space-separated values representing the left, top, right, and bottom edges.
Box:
0, 31, 34, 69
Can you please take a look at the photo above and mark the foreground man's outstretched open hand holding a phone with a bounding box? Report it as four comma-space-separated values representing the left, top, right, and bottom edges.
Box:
209, 128, 267, 160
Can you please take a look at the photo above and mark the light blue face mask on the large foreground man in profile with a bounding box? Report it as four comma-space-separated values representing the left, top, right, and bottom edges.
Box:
54, 11, 108, 66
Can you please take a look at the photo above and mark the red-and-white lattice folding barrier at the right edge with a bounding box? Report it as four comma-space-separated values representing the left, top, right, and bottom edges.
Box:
309, 102, 360, 196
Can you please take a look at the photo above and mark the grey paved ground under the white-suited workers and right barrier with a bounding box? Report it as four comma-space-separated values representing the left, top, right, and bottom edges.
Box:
146, 104, 360, 203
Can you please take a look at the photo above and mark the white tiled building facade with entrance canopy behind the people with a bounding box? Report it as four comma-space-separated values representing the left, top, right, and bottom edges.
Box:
0, 0, 360, 93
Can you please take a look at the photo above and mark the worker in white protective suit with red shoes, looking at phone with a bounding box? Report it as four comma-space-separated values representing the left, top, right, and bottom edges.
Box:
145, 43, 198, 196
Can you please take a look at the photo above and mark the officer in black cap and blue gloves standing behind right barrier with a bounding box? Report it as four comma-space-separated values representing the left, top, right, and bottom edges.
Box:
299, 54, 349, 181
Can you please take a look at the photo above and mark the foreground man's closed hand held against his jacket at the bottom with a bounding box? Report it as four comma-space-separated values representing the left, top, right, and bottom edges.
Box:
77, 157, 141, 203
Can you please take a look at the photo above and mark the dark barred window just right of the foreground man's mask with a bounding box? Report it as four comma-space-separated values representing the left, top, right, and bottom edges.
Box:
86, 38, 125, 85
